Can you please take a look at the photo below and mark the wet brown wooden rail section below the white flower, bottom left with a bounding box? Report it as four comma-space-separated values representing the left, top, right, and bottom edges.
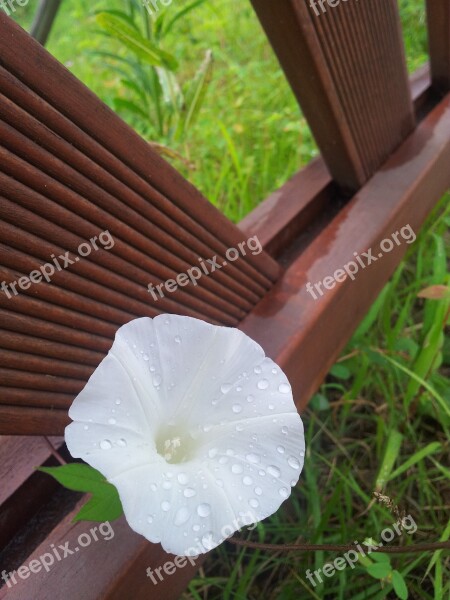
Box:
0, 499, 204, 600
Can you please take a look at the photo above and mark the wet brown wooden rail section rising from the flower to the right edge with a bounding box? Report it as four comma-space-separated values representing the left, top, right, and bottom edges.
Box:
239, 94, 450, 410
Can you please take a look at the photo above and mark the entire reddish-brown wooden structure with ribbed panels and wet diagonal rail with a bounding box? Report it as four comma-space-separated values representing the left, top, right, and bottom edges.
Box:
0, 0, 450, 600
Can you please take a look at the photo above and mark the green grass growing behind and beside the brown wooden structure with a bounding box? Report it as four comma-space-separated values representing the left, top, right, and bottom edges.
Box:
11, 0, 450, 600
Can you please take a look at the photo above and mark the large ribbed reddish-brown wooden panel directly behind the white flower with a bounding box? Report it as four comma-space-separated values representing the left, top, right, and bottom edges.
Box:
0, 12, 279, 434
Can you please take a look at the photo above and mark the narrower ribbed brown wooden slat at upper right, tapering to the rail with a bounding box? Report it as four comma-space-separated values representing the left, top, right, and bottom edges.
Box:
252, 0, 415, 192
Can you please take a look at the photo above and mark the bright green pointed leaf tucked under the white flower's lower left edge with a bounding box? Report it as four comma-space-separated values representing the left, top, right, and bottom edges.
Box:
39, 463, 123, 522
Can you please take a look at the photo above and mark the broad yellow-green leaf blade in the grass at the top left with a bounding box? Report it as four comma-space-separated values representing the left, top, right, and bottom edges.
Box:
96, 12, 178, 71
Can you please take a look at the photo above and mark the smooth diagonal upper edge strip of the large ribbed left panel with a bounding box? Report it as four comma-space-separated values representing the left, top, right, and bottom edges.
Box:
0, 13, 280, 281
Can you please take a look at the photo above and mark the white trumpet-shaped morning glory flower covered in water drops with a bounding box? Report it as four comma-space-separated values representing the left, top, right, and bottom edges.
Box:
66, 315, 304, 556
